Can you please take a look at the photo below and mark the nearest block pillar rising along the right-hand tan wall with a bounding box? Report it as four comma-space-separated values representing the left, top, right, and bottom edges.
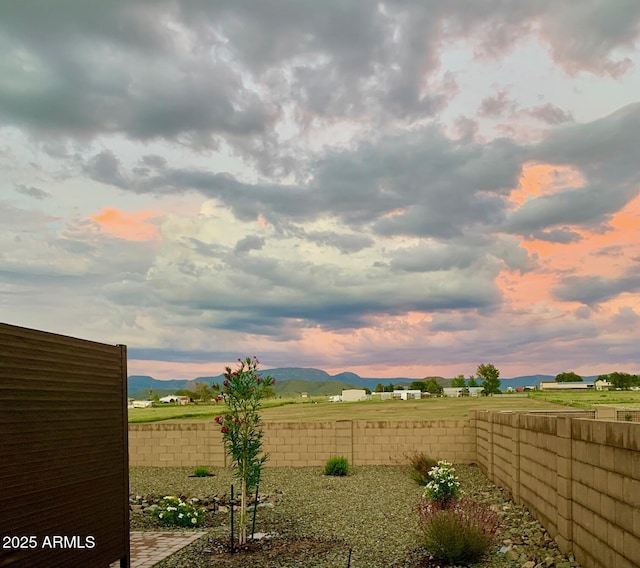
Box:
556, 416, 573, 554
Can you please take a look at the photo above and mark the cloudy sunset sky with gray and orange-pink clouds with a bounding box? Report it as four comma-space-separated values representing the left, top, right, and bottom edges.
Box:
0, 0, 640, 378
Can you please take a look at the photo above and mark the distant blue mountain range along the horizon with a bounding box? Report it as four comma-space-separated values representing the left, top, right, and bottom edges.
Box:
127, 367, 576, 398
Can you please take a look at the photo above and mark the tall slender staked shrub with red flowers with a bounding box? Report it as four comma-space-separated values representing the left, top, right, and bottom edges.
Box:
212, 357, 275, 545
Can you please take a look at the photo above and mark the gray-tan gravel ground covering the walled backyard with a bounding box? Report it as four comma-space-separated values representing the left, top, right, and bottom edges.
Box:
130, 466, 579, 568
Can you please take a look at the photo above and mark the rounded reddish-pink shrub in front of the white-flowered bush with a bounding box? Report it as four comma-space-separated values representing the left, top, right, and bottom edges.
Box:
418, 499, 498, 566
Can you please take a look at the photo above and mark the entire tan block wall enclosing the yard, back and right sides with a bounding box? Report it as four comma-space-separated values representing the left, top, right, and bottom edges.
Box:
129, 408, 640, 568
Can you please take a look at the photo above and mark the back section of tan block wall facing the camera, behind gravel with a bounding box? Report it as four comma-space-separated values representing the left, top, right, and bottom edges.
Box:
129, 420, 476, 467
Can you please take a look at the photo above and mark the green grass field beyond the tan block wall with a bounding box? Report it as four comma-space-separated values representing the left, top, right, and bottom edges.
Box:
129, 391, 640, 422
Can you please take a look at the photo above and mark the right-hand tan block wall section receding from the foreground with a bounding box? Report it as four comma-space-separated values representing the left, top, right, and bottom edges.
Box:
471, 412, 640, 568
